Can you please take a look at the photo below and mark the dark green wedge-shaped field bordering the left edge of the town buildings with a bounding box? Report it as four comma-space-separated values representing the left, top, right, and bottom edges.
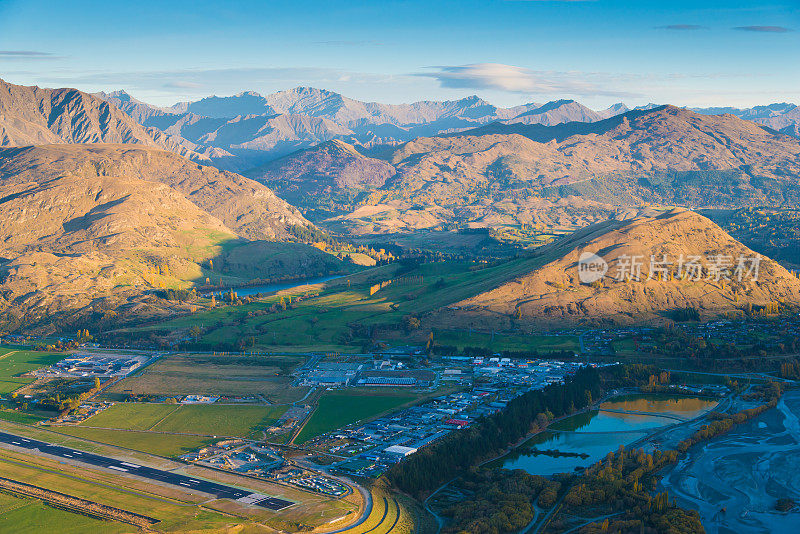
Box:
294, 390, 419, 444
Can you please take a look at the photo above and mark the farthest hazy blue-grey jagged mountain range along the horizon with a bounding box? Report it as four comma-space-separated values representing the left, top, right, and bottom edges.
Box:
97, 87, 800, 171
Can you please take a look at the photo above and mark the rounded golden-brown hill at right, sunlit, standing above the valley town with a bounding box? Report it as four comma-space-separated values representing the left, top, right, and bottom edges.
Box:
437, 209, 800, 325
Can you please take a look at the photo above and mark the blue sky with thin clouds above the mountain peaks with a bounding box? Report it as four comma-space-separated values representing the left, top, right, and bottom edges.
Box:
0, 0, 800, 108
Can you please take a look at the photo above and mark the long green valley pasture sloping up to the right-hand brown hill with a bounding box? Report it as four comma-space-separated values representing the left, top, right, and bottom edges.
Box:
128, 256, 551, 352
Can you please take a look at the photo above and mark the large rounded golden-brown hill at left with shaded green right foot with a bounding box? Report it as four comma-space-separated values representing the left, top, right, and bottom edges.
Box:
0, 144, 332, 330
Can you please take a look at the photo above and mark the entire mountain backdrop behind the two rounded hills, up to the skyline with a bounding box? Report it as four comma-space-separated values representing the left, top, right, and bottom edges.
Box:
0, 77, 800, 238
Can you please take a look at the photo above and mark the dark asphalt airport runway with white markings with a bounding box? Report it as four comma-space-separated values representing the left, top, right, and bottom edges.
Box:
0, 432, 294, 511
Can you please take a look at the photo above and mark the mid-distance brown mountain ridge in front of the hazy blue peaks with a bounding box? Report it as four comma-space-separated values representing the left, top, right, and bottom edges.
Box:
246, 106, 800, 235
